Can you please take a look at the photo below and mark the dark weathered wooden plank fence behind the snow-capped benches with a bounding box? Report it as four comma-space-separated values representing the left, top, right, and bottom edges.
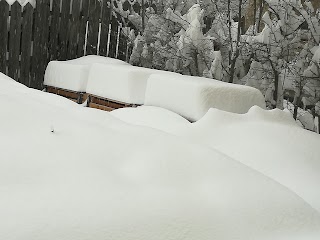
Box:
0, 0, 135, 89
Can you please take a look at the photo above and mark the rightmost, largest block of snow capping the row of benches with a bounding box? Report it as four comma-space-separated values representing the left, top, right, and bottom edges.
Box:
145, 74, 265, 121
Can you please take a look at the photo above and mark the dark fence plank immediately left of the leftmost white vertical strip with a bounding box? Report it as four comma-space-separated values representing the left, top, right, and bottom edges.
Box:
77, 0, 89, 57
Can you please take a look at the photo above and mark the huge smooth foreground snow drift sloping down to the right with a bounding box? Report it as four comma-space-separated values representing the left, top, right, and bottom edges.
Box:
0, 77, 320, 240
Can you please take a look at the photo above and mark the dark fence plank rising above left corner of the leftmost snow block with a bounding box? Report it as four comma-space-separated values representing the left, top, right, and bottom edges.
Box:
49, 0, 61, 60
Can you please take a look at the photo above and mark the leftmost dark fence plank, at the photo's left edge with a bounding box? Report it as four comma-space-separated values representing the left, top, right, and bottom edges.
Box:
0, 1, 9, 74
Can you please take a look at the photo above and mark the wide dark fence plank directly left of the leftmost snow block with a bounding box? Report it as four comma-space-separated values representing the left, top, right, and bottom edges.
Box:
30, 0, 50, 89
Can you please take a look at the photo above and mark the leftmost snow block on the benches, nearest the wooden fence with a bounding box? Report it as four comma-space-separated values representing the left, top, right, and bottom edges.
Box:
44, 55, 130, 92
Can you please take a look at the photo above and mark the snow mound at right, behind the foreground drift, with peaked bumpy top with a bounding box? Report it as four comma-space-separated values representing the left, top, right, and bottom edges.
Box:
172, 107, 320, 212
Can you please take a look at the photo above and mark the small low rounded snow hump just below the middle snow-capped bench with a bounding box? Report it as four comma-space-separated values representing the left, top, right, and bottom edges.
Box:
110, 106, 190, 133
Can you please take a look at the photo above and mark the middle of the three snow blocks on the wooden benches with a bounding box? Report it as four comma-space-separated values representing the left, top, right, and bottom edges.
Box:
87, 64, 178, 105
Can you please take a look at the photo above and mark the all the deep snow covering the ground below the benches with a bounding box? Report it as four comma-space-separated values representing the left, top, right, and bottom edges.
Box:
0, 75, 320, 240
